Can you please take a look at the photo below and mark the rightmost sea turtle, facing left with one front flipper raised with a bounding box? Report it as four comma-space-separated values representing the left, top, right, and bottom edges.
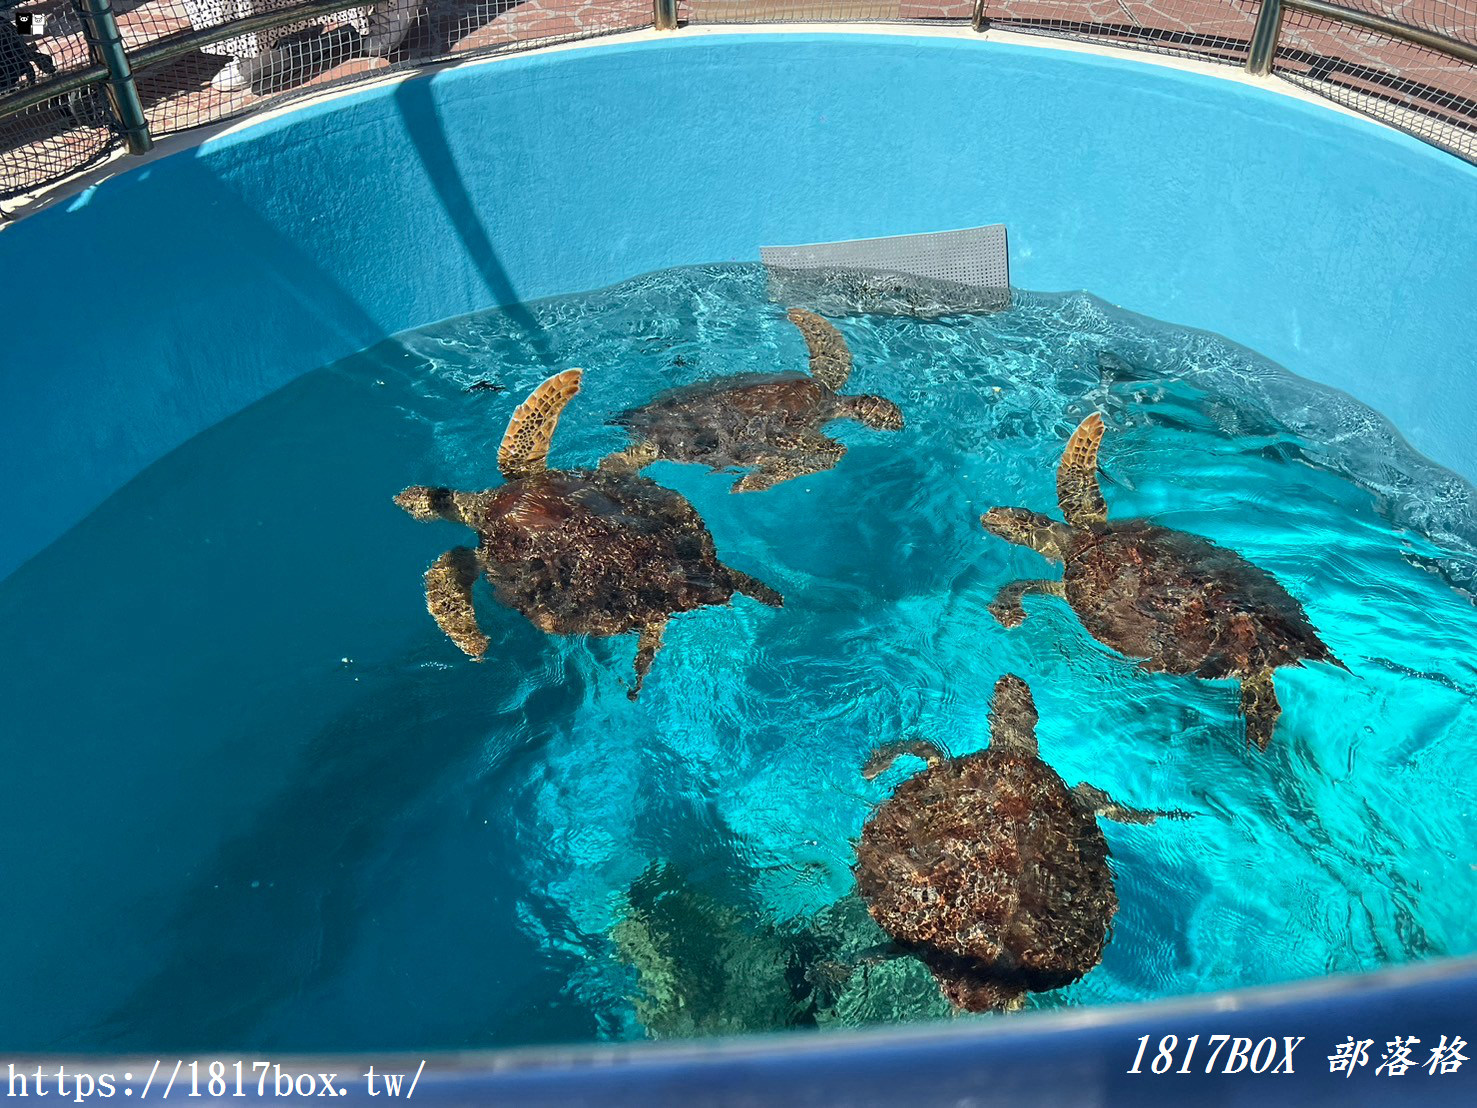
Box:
981, 412, 1347, 750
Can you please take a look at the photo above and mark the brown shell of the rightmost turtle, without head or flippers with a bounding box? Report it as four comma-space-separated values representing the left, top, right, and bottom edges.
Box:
1063, 520, 1334, 678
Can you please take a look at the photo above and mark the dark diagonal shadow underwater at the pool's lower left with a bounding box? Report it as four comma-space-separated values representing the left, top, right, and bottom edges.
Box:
86, 655, 582, 1050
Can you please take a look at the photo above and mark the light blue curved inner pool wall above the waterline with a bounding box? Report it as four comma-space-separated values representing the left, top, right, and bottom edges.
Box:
0, 33, 1477, 576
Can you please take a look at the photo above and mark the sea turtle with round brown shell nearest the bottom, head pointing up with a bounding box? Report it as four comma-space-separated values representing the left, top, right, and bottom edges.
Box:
855, 674, 1186, 1012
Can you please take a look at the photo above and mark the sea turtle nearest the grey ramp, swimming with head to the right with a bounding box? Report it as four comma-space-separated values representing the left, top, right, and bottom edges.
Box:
596, 309, 902, 492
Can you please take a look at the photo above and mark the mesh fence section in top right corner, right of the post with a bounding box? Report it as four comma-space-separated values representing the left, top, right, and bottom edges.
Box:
1273, 0, 1477, 163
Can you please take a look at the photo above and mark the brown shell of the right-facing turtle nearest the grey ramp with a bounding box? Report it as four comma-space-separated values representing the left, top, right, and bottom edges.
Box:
610, 374, 836, 468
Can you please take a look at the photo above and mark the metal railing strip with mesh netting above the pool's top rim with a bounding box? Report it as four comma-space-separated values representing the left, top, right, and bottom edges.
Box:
0, 0, 1477, 208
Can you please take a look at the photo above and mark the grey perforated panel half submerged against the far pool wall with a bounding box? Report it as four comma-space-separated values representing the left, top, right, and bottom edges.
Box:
759, 223, 1010, 318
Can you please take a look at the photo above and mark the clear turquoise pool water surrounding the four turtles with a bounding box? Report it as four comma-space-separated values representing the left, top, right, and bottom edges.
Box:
0, 266, 1477, 1050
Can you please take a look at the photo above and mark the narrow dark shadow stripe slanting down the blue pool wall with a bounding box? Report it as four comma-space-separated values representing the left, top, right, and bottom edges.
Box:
394, 78, 554, 366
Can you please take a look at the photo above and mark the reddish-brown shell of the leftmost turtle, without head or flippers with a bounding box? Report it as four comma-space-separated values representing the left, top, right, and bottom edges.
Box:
473, 470, 734, 635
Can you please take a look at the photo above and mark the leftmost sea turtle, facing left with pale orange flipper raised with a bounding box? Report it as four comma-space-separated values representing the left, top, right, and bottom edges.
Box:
394, 369, 784, 700
